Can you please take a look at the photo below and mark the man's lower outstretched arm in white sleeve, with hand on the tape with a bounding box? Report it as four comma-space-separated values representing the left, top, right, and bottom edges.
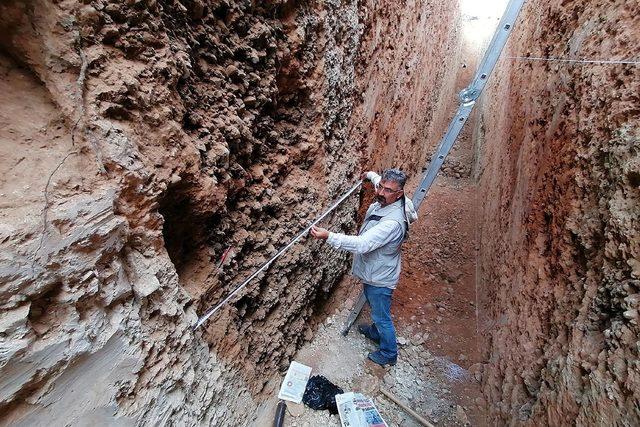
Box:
311, 221, 403, 254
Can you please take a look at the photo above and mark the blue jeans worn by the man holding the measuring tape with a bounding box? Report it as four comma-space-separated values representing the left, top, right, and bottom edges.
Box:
363, 283, 398, 359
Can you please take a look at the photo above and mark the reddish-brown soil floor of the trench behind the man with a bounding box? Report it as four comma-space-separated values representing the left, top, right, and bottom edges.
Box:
393, 179, 484, 425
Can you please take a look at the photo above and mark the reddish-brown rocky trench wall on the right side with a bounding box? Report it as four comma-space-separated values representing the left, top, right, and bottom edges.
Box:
478, 0, 640, 425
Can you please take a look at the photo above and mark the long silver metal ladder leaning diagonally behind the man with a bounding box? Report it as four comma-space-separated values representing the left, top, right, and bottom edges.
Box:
342, 0, 526, 336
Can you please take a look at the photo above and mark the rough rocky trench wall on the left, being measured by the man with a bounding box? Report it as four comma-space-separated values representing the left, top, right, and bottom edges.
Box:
0, 0, 456, 425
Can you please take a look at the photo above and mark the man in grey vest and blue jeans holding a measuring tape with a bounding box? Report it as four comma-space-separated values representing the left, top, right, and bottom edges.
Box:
311, 169, 417, 366
